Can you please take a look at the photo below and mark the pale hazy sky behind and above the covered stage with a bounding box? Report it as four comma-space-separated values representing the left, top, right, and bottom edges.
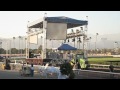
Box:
0, 11, 120, 38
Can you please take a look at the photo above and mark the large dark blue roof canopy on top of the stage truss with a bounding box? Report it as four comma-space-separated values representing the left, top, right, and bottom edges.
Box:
28, 16, 88, 29
